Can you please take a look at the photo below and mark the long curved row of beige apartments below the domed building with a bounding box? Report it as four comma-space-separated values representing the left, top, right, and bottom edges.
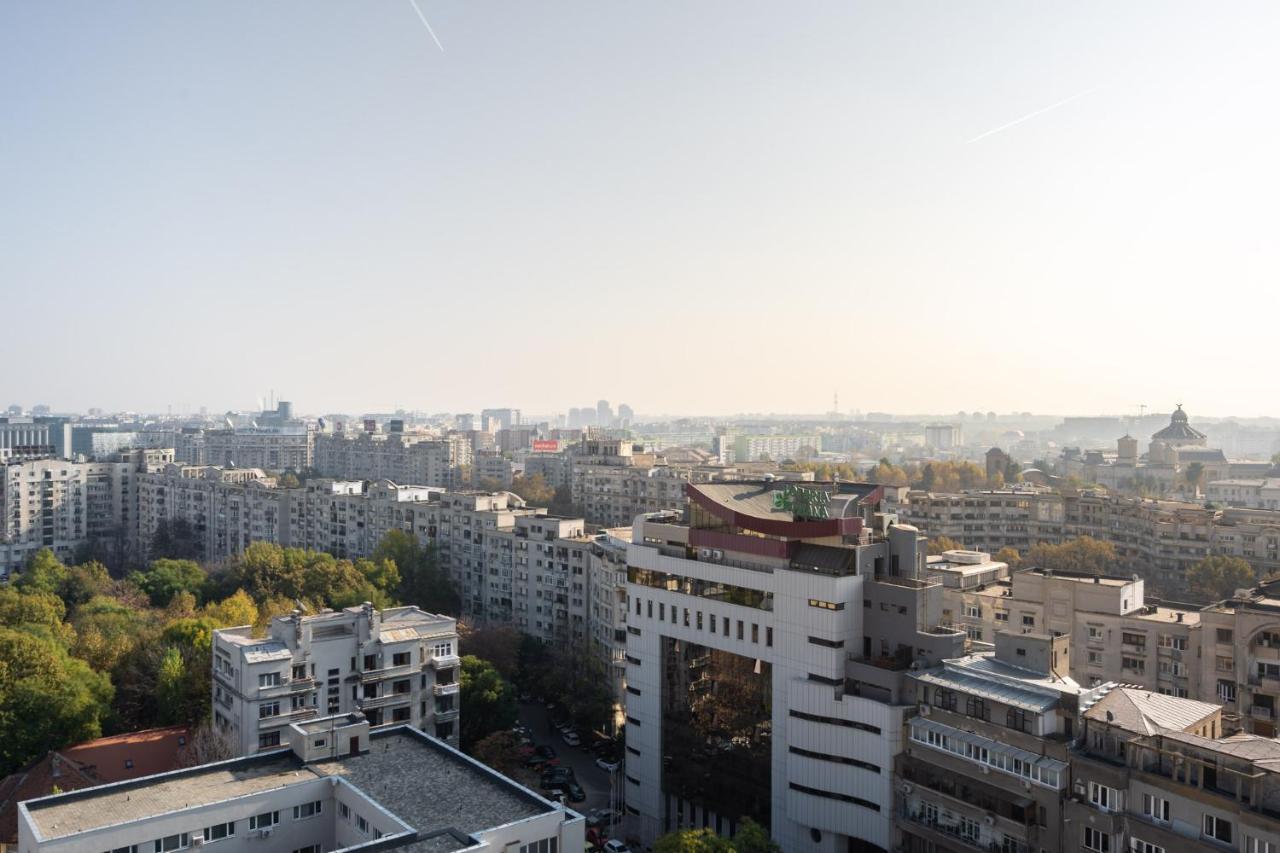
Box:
892, 489, 1280, 596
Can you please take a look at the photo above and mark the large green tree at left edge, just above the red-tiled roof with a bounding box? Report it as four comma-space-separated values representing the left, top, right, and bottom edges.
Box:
0, 628, 111, 775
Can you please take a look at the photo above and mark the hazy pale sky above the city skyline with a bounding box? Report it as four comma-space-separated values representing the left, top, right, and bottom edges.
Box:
0, 0, 1280, 415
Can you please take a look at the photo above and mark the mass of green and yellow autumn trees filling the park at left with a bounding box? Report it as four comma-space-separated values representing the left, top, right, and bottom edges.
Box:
0, 530, 460, 775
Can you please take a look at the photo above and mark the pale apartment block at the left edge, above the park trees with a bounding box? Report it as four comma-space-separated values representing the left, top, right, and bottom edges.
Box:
0, 451, 172, 578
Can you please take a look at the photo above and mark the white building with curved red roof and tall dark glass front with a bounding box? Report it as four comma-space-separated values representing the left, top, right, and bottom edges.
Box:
625, 482, 964, 852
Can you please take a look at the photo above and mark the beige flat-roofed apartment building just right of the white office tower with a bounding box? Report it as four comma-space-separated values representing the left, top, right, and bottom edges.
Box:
929, 552, 1213, 699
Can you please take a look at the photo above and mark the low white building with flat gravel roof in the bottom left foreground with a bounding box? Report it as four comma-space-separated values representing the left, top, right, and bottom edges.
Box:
18, 715, 585, 853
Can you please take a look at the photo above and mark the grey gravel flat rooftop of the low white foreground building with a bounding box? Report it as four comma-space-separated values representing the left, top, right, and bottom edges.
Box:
27, 726, 560, 853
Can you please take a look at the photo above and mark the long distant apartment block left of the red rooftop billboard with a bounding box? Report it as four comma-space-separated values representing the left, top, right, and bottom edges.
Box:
315, 433, 472, 488
